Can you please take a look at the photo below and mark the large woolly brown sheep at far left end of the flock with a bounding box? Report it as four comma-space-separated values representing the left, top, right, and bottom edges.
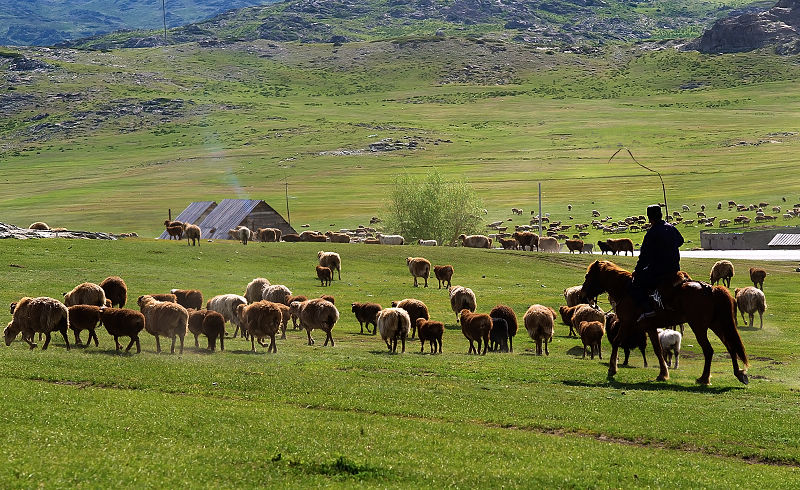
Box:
3, 296, 69, 350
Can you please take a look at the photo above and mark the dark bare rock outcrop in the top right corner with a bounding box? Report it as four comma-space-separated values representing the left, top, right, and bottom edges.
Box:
690, 0, 800, 54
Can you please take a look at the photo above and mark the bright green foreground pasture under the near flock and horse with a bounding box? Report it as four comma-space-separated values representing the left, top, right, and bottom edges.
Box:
0, 239, 800, 488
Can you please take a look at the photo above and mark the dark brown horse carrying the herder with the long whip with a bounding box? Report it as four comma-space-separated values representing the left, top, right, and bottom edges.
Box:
582, 260, 750, 385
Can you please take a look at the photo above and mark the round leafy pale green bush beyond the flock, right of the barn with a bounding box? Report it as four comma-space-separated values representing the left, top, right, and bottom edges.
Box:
384, 169, 483, 245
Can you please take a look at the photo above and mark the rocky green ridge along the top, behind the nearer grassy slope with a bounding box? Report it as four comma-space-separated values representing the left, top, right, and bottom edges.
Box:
71, 0, 762, 48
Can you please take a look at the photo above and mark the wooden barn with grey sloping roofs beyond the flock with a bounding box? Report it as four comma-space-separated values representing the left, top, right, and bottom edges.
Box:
159, 199, 297, 240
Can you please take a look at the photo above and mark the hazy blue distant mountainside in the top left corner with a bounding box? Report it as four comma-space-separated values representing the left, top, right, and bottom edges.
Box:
0, 0, 275, 46
